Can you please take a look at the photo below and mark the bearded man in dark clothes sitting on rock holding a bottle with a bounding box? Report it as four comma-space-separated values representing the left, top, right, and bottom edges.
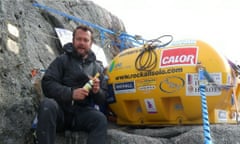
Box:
37, 26, 107, 144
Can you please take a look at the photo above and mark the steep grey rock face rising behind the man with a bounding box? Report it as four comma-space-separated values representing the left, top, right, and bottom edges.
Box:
0, 0, 125, 144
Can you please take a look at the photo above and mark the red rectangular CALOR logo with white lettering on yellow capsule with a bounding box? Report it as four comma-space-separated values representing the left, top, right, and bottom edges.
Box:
160, 47, 198, 67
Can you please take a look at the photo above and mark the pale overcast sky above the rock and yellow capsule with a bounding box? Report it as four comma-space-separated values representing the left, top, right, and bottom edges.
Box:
93, 0, 240, 62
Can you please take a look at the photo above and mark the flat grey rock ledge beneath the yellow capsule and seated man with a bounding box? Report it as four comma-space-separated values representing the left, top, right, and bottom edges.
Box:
59, 123, 240, 144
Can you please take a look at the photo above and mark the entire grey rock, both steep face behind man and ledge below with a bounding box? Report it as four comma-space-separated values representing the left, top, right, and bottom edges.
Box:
0, 0, 240, 144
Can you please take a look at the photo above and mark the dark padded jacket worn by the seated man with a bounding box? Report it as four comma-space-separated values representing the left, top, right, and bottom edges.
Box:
42, 43, 107, 111
